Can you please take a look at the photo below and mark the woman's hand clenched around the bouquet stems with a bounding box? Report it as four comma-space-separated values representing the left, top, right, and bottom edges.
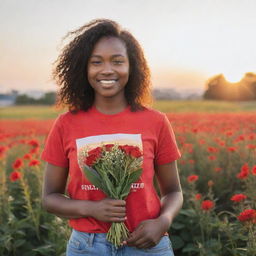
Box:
90, 198, 126, 222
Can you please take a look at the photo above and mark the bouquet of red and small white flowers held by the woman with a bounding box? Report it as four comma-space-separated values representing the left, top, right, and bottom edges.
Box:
83, 144, 142, 247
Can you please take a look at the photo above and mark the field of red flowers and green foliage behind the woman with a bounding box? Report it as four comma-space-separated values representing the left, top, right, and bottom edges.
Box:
0, 112, 256, 256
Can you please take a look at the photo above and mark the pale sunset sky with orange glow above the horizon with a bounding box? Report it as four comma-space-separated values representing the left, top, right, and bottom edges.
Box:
0, 0, 256, 94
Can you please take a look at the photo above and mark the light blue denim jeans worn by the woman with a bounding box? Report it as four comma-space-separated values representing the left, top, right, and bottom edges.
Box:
66, 229, 174, 256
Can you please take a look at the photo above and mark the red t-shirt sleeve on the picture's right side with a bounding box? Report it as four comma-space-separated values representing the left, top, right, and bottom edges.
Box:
155, 114, 181, 165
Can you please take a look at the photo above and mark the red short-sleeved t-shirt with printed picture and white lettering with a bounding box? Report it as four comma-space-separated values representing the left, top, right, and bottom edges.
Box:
42, 106, 180, 233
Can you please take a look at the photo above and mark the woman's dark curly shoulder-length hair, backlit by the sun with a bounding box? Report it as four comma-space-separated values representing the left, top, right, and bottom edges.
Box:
53, 19, 152, 112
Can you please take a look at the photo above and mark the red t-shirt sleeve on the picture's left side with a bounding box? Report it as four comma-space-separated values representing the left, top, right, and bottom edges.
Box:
41, 116, 69, 168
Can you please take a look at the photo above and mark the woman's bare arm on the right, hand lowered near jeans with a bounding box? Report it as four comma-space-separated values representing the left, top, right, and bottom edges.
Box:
124, 161, 183, 249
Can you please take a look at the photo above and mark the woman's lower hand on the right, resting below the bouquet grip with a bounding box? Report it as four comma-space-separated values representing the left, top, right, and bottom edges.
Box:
123, 217, 170, 249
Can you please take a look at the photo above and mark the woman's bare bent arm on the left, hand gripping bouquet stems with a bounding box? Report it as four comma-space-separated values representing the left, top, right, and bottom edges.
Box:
42, 163, 125, 222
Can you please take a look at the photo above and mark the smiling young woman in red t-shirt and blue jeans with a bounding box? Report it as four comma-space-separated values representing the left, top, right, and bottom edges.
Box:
42, 19, 183, 256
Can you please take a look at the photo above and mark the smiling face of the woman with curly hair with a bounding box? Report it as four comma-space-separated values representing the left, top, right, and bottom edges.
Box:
87, 37, 129, 99
